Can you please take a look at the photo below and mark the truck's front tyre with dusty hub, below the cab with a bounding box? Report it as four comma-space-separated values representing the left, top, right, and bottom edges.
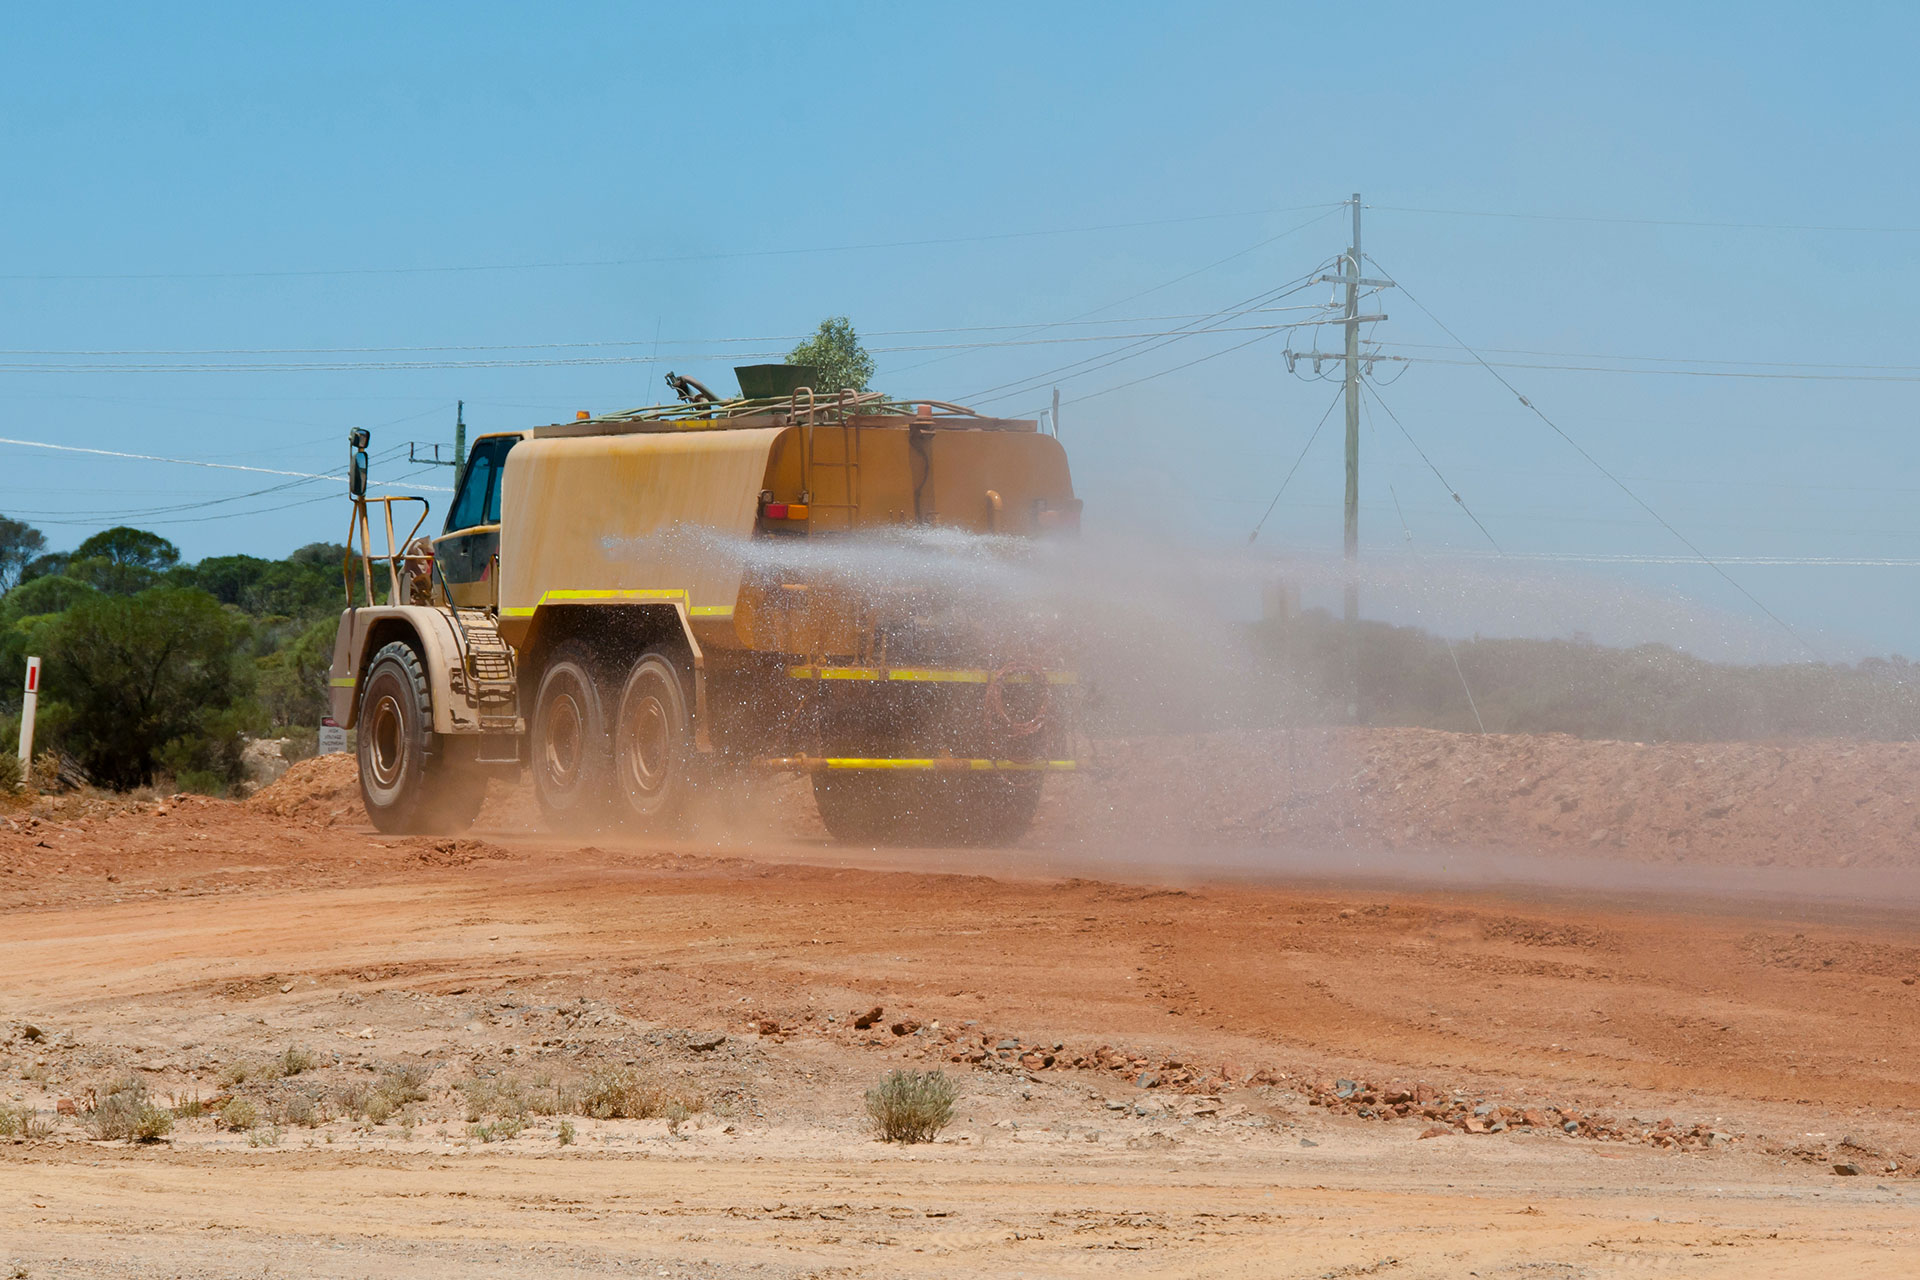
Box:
357, 641, 486, 835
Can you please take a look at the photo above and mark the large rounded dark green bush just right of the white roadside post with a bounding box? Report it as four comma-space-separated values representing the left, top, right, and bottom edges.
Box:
33, 587, 253, 787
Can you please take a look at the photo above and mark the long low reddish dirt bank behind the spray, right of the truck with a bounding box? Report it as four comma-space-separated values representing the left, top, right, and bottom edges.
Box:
1037, 729, 1920, 867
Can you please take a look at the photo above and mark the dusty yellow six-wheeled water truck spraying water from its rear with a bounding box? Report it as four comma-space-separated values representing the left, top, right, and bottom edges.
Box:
332, 379, 1079, 842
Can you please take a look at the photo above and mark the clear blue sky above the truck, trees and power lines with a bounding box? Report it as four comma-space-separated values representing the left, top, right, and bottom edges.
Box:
0, 4, 1920, 656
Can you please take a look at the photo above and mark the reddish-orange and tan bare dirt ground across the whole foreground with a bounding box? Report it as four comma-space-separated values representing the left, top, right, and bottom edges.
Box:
0, 744, 1920, 1276
